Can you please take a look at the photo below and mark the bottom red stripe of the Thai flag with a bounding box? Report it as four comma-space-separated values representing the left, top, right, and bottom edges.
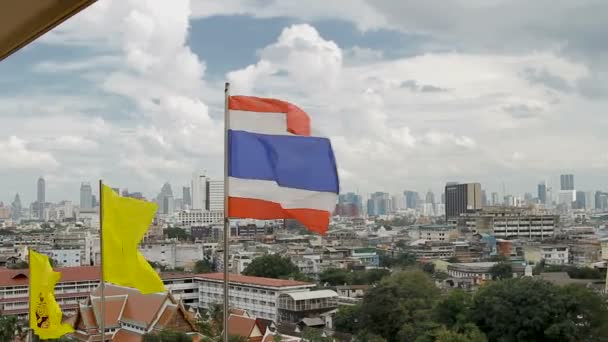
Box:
228, 197, 330, 234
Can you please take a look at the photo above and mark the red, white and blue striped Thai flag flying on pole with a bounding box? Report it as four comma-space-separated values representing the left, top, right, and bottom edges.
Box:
228, 96, 339, 234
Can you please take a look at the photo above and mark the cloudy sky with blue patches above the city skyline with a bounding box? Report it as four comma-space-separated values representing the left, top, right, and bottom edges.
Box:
0, 0, 608, 202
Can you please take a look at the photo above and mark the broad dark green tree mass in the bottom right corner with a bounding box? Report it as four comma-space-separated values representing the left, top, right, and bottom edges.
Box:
470, 278, 608, 341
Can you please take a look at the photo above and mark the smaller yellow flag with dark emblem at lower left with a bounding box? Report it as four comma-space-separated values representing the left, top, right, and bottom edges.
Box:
29, 250, 74, 340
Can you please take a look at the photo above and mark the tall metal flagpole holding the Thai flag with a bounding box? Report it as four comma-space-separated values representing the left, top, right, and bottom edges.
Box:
224, 82, 230, 342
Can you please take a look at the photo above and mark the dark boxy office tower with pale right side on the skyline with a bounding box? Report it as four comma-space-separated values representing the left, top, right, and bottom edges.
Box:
445, 183, 482, 220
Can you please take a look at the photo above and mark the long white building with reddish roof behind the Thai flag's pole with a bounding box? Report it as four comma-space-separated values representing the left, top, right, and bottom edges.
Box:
194, 273, 316, 321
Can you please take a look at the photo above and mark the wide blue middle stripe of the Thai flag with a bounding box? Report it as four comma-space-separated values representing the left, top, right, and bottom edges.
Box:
228, 130, 339, 193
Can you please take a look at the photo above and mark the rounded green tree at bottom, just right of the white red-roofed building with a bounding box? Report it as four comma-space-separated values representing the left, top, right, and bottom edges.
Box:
361, 270, 439, 341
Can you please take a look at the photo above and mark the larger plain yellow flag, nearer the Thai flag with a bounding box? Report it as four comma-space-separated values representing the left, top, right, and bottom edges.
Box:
101, 185, 165, 294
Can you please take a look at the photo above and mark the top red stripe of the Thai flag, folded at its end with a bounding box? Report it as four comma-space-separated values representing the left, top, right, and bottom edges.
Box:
228, 96, 310, 136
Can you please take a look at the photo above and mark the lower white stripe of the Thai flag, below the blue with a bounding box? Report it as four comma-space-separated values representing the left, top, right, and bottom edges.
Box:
229, 177, 338, 213
